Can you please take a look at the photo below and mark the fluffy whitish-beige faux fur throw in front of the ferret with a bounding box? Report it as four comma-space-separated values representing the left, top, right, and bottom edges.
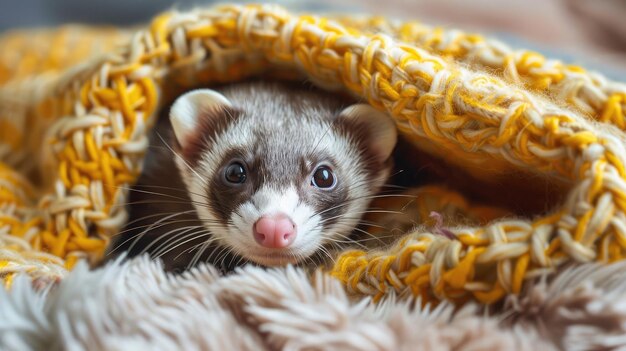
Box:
0, 258, 626, 351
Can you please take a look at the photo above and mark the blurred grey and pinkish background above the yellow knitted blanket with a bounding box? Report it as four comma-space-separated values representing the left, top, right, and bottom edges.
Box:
0, 0, 626, 80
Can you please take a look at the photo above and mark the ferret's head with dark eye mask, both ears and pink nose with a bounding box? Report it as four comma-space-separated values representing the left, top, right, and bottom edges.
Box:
170, 84, 397, 266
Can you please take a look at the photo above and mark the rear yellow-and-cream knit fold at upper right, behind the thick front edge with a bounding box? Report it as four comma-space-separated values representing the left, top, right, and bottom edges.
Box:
337, 16, 626, 129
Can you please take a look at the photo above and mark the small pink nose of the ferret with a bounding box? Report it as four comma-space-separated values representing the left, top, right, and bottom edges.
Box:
253, 214, 296, 249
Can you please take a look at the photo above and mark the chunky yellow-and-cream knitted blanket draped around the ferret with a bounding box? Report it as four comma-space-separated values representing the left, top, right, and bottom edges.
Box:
0, 5, 626, 303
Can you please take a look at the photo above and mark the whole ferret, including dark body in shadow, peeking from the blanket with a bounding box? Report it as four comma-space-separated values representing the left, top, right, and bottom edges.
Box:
109, 82, 397, 271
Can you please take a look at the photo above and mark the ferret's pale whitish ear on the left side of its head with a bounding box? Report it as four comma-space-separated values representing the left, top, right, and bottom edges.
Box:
170, 89, 232, 147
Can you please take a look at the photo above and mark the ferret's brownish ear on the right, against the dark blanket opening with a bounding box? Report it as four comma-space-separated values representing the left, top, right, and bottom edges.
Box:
340, 104, 398, 162
